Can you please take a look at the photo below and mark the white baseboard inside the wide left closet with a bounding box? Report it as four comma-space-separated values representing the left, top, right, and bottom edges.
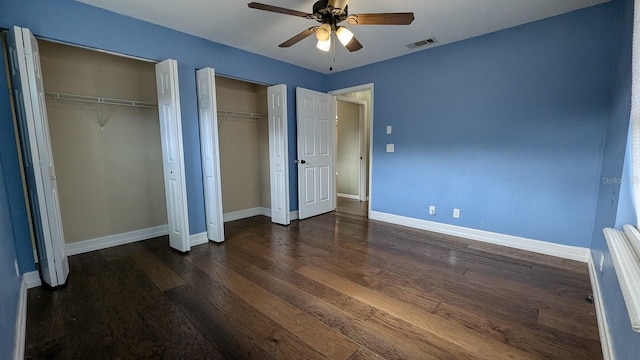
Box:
64, 225, 169, 256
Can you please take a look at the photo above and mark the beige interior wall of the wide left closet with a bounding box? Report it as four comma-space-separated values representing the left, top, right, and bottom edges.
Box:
40, 41, 167, 243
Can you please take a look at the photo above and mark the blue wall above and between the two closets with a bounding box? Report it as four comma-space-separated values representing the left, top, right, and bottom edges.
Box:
0, 0, 327, 246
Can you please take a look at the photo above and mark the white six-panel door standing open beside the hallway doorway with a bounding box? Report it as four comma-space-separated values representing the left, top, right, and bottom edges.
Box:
296, 88, 336, 219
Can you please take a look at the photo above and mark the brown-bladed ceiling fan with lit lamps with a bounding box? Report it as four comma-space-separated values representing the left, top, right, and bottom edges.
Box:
248, 0, 414, 52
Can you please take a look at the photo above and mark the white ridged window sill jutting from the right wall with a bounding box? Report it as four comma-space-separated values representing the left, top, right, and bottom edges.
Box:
603, 225, 640, 332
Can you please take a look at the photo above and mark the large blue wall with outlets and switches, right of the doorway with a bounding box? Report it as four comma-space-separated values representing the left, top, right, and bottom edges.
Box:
329, 4, 615, 247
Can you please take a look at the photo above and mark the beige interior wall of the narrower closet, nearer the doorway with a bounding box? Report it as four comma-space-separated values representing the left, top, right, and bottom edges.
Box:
216, 76, 271, 218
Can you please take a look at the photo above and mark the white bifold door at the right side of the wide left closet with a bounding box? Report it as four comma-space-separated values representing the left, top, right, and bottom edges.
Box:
156, 59, 191, 252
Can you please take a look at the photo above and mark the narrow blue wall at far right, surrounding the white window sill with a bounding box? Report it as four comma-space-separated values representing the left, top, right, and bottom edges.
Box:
592, 0, 640, 359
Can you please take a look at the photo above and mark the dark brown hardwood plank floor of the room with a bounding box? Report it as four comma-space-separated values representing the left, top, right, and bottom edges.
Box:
26, 209, 602, 359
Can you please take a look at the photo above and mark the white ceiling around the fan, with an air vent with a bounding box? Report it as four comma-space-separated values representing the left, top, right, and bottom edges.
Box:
77, 0, 610, 73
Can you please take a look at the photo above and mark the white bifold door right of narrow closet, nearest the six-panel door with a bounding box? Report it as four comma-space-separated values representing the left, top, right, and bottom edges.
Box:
267, 85, 291, 225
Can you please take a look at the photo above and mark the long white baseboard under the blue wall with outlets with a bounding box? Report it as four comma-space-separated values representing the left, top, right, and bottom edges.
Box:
370, 211, 591, 263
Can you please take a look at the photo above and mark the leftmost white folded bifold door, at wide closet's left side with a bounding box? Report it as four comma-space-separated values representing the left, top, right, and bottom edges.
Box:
7, 26, 69, 287
